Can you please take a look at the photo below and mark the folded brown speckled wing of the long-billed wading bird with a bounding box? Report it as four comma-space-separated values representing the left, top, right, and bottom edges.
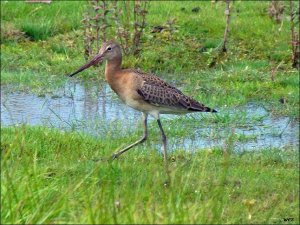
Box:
137, 81, 214, 112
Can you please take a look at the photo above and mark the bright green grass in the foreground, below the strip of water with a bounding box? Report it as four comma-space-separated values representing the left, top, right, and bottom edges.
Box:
1, 126, 299, 224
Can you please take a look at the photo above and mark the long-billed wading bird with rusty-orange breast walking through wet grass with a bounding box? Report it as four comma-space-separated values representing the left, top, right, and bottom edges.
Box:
69, 41, 216, 162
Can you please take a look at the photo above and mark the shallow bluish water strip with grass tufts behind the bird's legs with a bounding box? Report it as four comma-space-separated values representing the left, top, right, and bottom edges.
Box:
1, 82, 299, 151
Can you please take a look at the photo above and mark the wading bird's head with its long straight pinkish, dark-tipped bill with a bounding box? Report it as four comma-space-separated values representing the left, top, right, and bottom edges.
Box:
69, 41, 122, 77
